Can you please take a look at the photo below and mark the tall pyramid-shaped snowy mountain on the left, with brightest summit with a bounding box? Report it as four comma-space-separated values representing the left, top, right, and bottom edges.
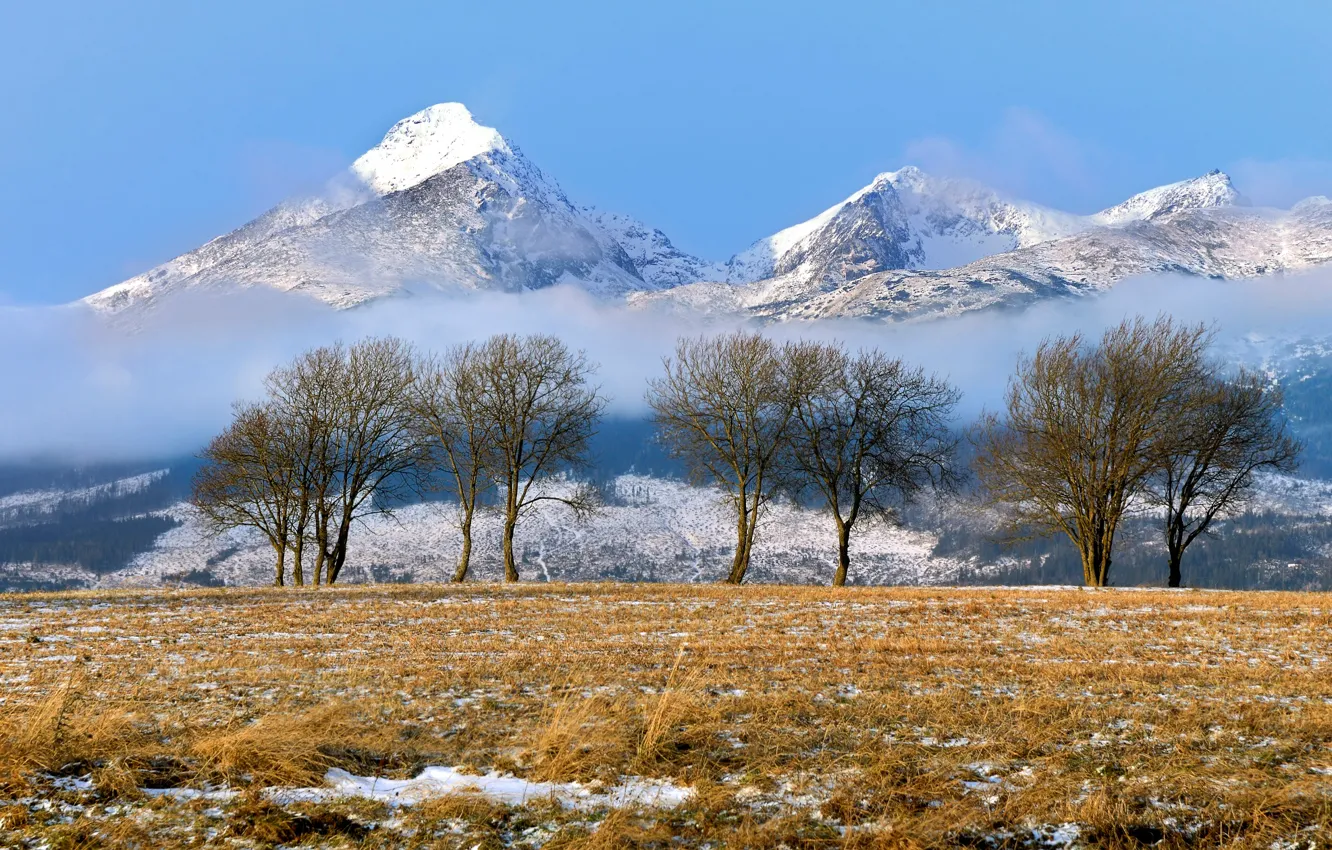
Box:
85, 104, 708, 312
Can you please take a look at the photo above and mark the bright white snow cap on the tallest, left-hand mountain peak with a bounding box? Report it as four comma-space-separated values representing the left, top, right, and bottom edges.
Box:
352, 103, 509, 195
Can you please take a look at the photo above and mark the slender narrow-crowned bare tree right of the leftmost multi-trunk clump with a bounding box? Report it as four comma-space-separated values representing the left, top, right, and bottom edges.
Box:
413, 342, 500, 581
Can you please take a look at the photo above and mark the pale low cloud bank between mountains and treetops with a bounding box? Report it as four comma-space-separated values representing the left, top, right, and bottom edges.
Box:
0, 272, 1332, 462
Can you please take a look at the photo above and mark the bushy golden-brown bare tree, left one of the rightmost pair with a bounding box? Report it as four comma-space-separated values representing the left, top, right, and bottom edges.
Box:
975, 317, 1209, 586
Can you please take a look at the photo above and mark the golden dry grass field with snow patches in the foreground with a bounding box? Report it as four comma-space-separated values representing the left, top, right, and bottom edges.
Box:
0, 585, 1332, 850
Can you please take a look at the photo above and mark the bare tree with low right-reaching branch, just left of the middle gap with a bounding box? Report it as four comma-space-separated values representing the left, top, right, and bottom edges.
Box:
476, 334, 606, 581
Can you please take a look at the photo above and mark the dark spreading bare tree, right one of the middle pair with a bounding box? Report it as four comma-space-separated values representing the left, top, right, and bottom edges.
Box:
789, 342, 960, 588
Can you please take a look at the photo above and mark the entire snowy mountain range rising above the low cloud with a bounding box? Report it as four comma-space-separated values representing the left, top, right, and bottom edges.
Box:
84, 104, 1332, 321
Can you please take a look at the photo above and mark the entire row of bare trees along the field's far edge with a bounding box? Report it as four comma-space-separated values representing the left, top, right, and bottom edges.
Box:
194, 317, 1300, 586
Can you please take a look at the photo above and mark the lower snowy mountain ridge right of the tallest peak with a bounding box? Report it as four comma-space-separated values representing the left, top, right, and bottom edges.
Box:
630, 169, 1332, 320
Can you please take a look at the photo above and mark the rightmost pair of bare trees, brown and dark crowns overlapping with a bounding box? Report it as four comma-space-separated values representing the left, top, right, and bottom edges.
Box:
974, 317, 1300, 588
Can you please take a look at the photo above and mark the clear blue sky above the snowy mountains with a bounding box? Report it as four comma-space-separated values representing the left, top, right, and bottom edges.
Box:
0, 0, 1332, 304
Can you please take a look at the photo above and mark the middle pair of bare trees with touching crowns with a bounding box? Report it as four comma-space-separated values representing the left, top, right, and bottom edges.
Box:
647, 332, 959, 586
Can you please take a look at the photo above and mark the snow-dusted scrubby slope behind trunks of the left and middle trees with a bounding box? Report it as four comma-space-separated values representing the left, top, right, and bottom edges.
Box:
97, 476, 962, 586
